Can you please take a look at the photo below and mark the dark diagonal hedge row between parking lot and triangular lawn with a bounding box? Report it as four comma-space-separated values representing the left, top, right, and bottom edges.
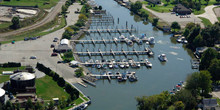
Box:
37, 63, 79, 100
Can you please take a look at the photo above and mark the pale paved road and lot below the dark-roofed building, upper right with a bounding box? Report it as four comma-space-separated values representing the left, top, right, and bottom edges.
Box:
142, 5, 204, 28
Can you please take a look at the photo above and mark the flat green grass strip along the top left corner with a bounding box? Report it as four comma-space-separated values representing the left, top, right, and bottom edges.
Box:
0, 0, 59, 9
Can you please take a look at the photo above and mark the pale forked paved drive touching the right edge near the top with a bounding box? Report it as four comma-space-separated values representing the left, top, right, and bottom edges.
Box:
196, 5, 218, 24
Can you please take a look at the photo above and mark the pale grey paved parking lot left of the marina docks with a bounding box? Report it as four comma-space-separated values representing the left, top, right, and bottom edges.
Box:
0, 3, 82, 83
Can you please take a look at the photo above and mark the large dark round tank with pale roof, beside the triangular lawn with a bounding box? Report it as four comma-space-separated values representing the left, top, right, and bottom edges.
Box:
10, 72, 36, 92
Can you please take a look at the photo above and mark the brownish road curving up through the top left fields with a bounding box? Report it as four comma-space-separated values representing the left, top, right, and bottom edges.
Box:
0, 0, 66, 38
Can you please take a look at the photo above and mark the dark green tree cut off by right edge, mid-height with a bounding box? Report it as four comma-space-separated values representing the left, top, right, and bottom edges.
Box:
208, 58, 220, 82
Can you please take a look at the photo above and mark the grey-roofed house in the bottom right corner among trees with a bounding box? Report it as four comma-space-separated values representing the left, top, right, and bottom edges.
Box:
202, 99, 218, 110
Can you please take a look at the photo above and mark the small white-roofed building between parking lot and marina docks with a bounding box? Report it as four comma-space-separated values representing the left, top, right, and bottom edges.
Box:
54, 39, 73, 52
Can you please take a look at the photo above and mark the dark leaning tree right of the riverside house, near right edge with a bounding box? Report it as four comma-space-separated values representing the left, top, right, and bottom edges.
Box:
199, 48, 218, 70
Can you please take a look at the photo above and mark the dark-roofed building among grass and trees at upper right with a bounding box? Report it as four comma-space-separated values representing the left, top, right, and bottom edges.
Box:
173, 4, 192, 15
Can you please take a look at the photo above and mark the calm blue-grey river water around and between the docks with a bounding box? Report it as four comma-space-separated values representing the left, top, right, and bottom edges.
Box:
76, 0, 196, 110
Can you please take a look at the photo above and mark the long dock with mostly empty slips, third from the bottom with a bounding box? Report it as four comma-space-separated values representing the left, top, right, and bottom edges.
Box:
73, 49, 148, 57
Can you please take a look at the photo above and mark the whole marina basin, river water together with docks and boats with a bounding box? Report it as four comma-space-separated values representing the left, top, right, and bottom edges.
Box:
71, 0, 198, 110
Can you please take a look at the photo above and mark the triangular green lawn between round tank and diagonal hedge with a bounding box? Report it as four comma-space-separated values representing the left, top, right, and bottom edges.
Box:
35, 75, 69, 100
